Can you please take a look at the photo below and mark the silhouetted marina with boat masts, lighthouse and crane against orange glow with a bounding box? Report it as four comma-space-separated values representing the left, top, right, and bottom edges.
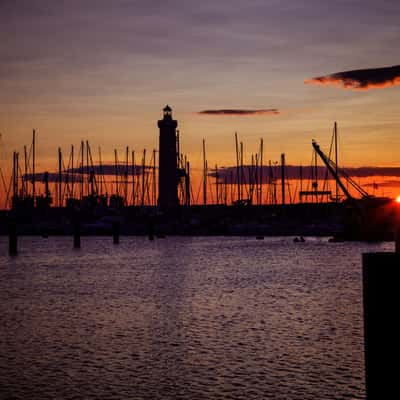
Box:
0, 105, 398, 240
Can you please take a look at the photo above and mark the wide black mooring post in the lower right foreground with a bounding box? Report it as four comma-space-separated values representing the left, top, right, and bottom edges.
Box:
362, 252, 400, 400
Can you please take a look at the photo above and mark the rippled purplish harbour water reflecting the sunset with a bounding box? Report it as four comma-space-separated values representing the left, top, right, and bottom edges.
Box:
0, 237, 392, 400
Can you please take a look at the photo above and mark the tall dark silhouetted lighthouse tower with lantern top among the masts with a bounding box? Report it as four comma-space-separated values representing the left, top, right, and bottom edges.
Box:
158, 105, 179, 209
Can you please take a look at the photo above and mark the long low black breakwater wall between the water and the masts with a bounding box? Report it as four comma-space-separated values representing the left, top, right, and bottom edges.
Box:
0, 203, 345, 236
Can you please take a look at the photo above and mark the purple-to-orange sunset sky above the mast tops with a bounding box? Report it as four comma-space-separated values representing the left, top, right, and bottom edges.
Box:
0, 0, 400, 177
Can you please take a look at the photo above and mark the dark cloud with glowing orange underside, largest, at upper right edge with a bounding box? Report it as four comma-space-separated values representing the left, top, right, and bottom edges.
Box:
304, 65, 400, 90
